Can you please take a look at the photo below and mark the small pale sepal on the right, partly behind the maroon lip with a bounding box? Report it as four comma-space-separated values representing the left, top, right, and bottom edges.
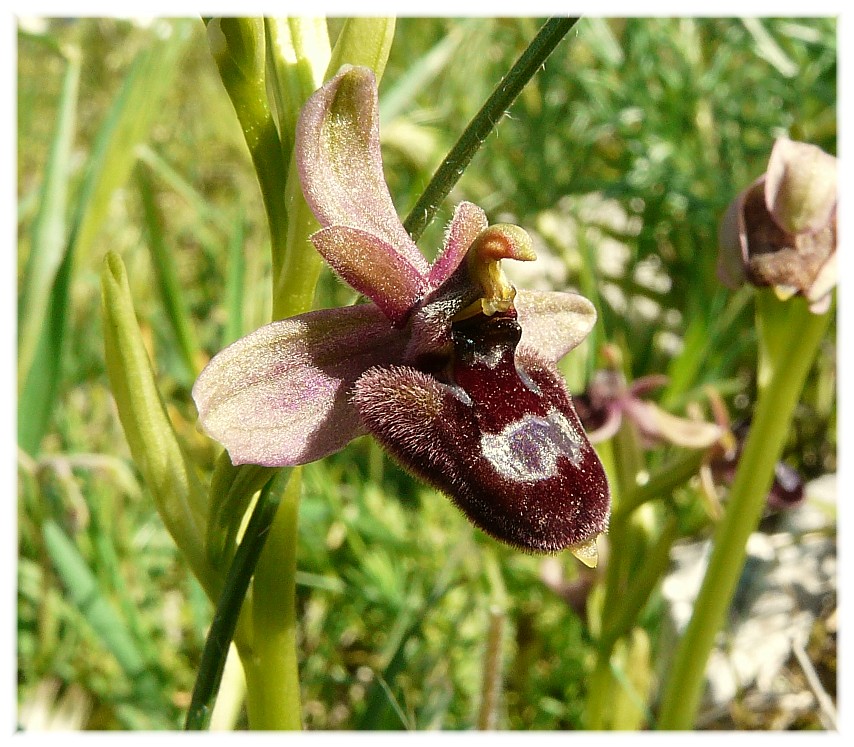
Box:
515, 290, 596, 363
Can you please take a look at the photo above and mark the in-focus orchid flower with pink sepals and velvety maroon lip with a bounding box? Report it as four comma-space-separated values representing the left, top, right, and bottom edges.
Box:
193, 66, 610, 562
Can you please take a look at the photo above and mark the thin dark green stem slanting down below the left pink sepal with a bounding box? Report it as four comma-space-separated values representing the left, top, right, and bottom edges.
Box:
184, 472, 285, 730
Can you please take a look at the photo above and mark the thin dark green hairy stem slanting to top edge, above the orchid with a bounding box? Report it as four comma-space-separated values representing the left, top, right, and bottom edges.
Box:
403, 18, 579, 241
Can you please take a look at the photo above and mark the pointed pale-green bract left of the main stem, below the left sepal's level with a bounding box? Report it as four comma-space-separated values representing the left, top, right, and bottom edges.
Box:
101, 252, 217, 596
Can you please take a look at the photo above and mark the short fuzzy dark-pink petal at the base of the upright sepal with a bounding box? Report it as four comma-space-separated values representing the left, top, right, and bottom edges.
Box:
311, 226, 426, 323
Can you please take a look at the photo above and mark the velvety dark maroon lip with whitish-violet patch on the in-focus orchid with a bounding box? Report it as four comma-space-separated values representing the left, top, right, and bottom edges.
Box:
354, 317, 610, 552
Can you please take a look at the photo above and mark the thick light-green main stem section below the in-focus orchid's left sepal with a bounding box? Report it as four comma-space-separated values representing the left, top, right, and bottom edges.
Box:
244, 468, 302, 730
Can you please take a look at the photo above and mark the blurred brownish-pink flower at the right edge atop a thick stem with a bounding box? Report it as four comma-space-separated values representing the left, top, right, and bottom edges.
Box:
718, 138, 837, 313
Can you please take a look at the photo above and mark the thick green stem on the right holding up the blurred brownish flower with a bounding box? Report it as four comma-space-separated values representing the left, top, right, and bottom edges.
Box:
658, 292, 832, 730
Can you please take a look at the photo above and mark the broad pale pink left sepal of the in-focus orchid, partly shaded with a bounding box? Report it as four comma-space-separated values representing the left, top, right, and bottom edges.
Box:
193, 304, 402, 467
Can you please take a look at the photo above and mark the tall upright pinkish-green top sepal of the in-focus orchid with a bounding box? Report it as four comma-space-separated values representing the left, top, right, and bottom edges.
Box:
295, 65, 427, 275
